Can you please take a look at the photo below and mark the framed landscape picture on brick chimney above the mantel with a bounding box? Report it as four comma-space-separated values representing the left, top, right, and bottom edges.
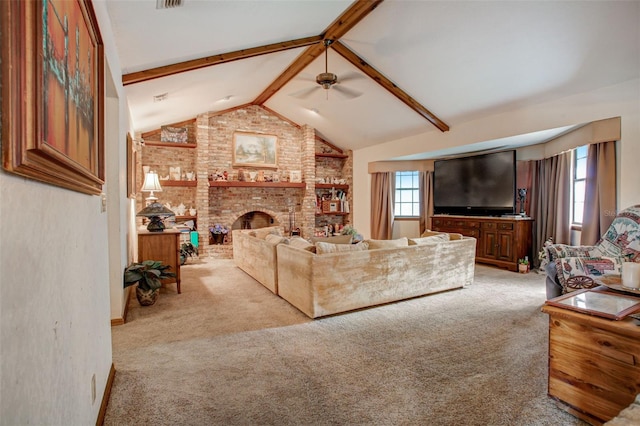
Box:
233, 132, 278, 168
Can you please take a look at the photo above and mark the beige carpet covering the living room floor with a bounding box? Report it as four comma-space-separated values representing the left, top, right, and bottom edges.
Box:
105, 259, 584, 426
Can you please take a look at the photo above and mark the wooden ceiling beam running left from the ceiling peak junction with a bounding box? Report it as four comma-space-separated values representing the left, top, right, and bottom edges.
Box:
122, 35, 323, 86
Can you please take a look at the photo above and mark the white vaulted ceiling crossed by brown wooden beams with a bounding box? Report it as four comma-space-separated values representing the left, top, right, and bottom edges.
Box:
107, 0, 640, 156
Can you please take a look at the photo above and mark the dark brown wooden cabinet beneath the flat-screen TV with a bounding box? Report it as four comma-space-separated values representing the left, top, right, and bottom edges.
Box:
431, 215, 533, 271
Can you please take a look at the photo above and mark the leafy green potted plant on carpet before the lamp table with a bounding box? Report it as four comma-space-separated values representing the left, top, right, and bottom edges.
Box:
124, 260, 176, 306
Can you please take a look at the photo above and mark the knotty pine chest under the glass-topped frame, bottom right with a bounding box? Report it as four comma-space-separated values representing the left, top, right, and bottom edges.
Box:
542, 305, 640, 425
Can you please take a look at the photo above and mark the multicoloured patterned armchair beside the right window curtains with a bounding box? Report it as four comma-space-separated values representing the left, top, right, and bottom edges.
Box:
545, 205, 640, 299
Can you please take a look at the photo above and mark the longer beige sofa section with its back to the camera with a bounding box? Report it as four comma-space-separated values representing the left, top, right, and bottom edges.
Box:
277, 236, 476, 318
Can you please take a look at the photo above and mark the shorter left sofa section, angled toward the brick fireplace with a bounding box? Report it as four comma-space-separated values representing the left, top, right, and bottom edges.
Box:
231, 226, 283, 294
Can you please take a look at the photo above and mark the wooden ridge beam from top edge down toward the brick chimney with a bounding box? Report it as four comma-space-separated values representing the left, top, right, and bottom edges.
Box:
252, 0, 383, 105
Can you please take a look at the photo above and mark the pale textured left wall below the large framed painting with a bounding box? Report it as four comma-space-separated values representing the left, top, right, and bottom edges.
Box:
0, 171, 111, 425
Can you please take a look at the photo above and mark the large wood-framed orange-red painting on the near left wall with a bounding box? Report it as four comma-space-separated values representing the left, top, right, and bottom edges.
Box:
0, 0, 104, 195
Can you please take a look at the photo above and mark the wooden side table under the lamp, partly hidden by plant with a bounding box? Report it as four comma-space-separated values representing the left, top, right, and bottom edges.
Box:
138, 229, 180, 294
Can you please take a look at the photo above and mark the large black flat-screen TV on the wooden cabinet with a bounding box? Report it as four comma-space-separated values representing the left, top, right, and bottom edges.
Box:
433, 151, 516, 216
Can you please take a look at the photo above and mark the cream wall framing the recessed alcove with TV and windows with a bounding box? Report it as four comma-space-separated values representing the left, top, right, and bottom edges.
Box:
353, 79, 640, 238
